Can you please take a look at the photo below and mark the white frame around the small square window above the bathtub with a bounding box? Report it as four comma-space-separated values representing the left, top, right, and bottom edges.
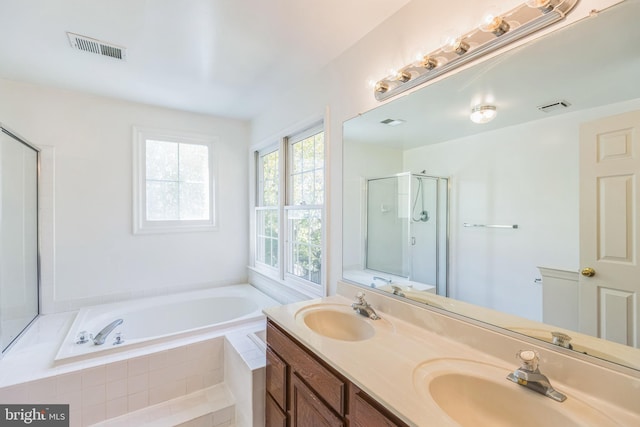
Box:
133, 126, 218, 234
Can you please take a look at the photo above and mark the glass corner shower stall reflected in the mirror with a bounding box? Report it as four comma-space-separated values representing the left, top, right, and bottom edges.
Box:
365, 172, 449, 295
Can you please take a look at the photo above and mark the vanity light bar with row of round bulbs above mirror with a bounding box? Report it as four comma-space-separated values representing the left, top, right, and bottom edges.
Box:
374, 0, 578, 101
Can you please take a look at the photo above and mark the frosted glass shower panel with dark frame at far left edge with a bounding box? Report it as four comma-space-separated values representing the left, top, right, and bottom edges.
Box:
0, 125, 39, 352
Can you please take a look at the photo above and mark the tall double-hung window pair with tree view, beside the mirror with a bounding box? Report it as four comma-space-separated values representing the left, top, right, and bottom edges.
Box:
255, 126, 325, 295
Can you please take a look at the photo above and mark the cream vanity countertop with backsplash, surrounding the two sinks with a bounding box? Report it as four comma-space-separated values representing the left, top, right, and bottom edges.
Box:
265, 282, 640, 426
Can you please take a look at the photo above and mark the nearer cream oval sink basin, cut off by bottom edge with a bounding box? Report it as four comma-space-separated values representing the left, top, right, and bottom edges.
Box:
414, 359, 617, 427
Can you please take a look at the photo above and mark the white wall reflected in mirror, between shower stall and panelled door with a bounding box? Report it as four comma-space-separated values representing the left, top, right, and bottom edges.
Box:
405, 110, 579, 320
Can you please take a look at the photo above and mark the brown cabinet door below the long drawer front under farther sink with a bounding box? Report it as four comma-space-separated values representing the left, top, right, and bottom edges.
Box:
291, 374, 344, 427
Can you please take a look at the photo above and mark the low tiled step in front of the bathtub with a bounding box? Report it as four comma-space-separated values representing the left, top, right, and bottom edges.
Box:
94, 383, 235, 427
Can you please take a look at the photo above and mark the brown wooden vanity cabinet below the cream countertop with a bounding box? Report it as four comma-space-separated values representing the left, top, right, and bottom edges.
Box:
265, 320, 406, 427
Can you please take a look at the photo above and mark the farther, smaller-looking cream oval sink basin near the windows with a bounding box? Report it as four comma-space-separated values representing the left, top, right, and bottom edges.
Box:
301, 308, 375, 341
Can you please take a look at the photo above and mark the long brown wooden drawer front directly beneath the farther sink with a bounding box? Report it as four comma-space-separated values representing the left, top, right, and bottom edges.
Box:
267, 322, 346, 416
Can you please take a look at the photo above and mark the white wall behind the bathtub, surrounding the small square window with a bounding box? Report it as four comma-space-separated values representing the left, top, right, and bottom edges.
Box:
0, 80, 249, 312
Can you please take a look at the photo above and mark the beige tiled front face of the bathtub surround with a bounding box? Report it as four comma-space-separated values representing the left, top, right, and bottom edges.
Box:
0, 337, 224, 426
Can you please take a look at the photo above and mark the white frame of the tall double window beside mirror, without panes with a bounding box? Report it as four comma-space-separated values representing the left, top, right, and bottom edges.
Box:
252, 121, 328, 297
